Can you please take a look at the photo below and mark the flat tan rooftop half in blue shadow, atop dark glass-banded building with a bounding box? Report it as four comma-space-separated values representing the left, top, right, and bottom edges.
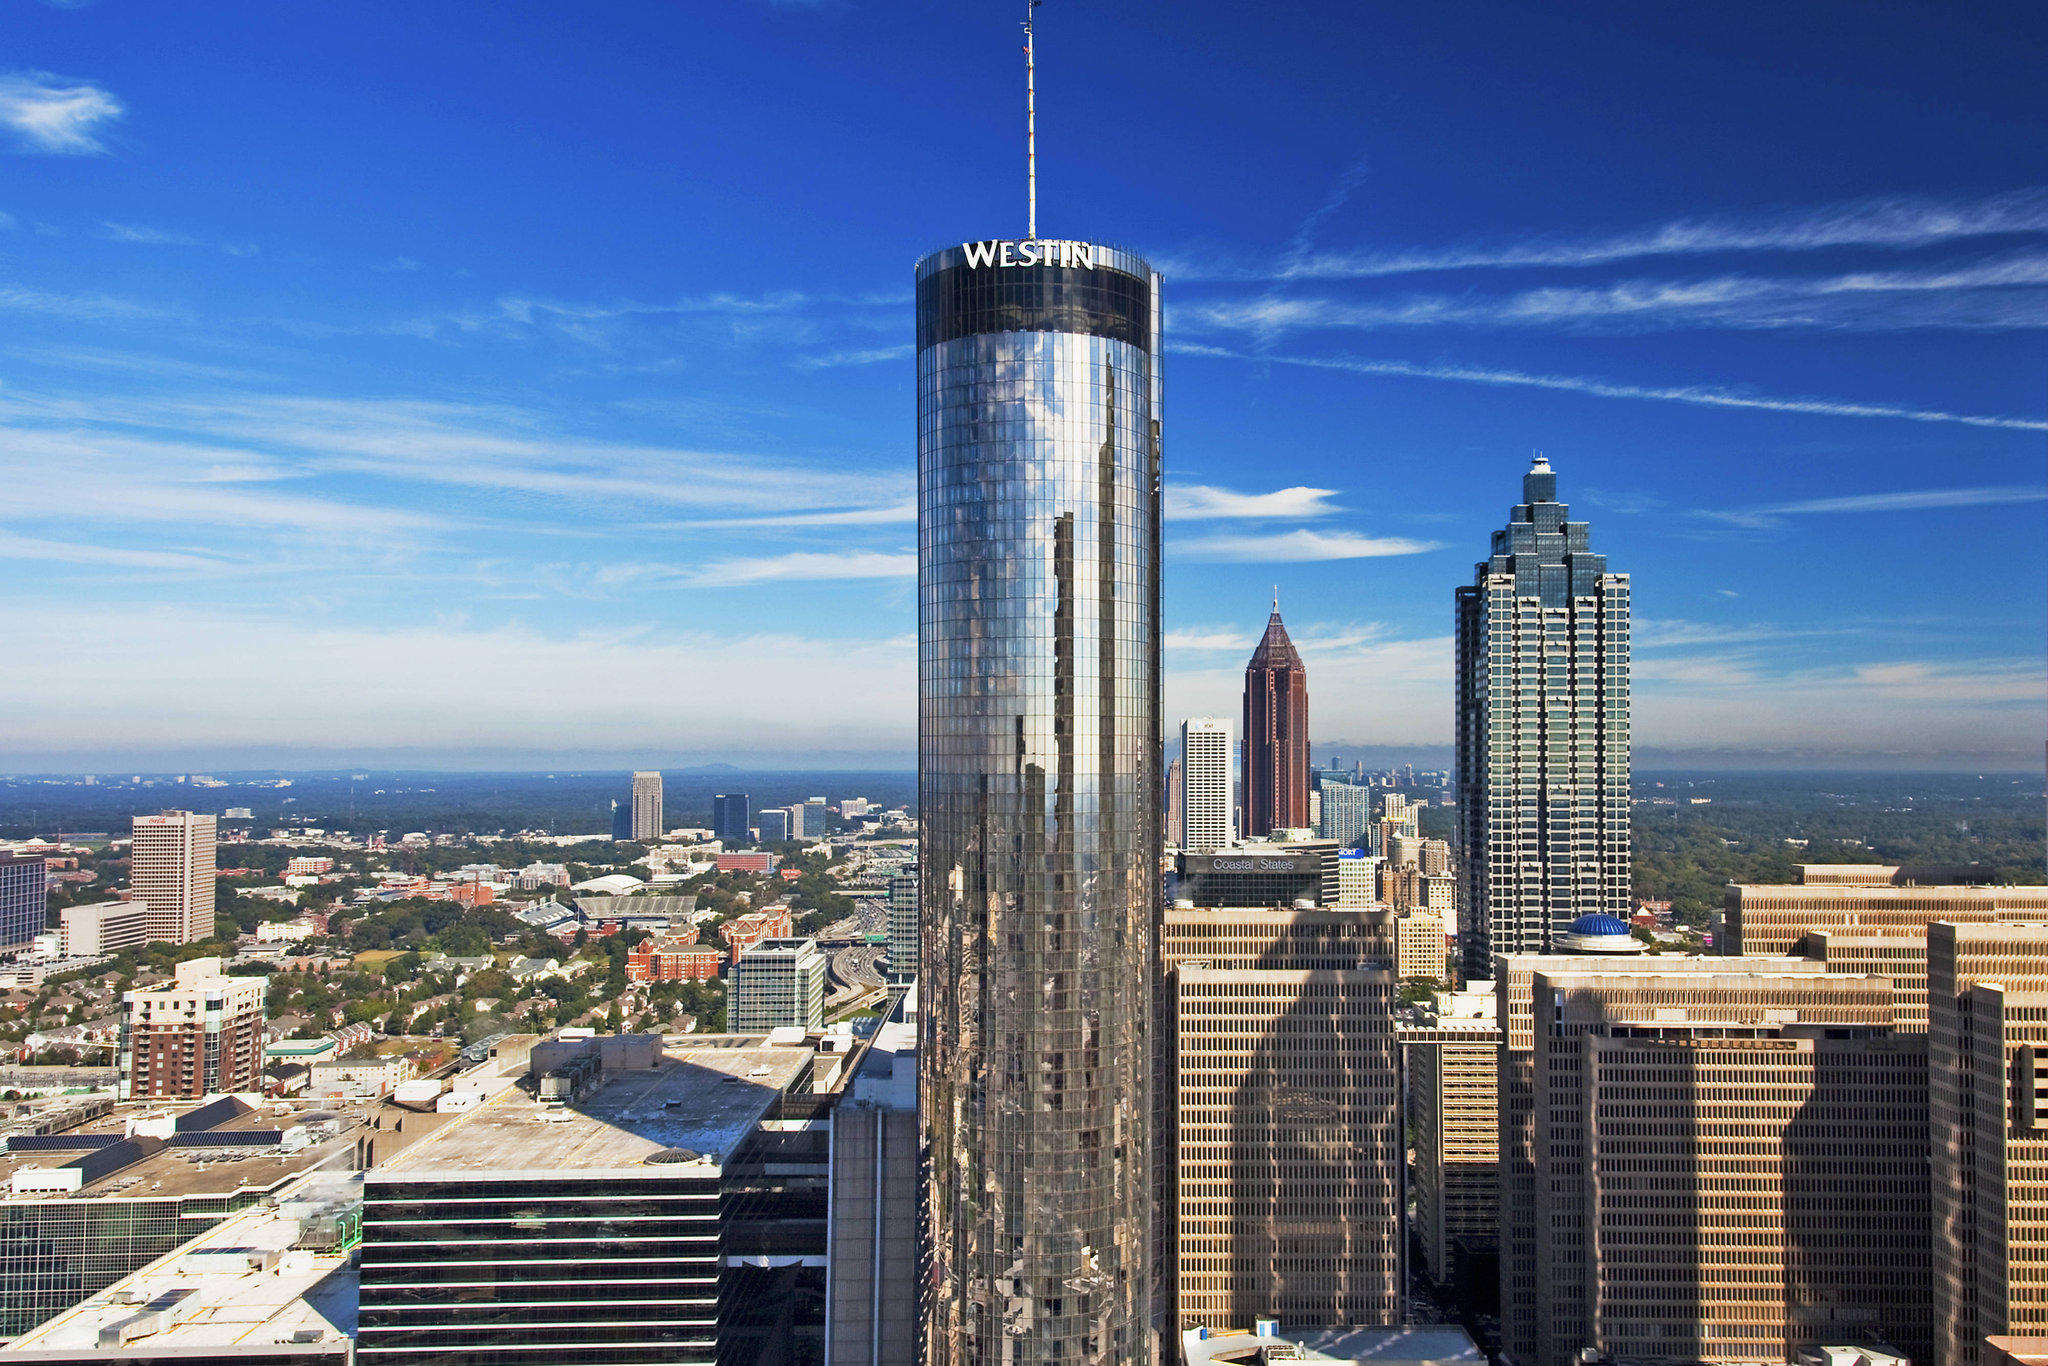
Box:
371, 1034, 813, 1182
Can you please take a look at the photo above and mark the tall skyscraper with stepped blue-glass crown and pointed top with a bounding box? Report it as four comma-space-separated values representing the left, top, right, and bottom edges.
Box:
1456, 457, 1630, 977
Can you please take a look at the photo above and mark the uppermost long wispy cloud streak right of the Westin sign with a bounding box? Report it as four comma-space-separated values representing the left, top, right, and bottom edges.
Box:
1184, 188, 2048, 281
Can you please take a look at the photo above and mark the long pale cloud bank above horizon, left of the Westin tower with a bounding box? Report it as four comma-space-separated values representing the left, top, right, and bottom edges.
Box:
0, 602, 918, 754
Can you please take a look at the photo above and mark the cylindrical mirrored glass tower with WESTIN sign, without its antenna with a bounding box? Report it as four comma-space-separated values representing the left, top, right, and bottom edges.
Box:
918, 248, 1163, 1366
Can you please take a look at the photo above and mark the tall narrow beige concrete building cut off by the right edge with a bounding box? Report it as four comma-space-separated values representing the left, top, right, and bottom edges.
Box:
1927, 924, 2048, 1366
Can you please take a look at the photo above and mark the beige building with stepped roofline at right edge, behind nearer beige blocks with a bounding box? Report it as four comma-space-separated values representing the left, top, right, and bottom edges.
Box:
1720, 864, 2048, 1030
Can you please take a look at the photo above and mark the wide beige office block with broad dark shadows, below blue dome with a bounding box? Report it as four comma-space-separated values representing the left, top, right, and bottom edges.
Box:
1516, 958, 1931, 1366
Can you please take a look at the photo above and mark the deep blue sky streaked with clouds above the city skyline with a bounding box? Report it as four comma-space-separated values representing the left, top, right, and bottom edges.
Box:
0, 0, 2048, 770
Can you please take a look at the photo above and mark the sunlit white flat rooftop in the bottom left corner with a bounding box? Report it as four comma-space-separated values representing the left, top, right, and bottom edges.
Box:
0, 1171, 362, 1362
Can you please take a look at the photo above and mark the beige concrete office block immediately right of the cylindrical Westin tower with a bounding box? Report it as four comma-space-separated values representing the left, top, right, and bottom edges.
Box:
1159, 905, 1403, 1327
